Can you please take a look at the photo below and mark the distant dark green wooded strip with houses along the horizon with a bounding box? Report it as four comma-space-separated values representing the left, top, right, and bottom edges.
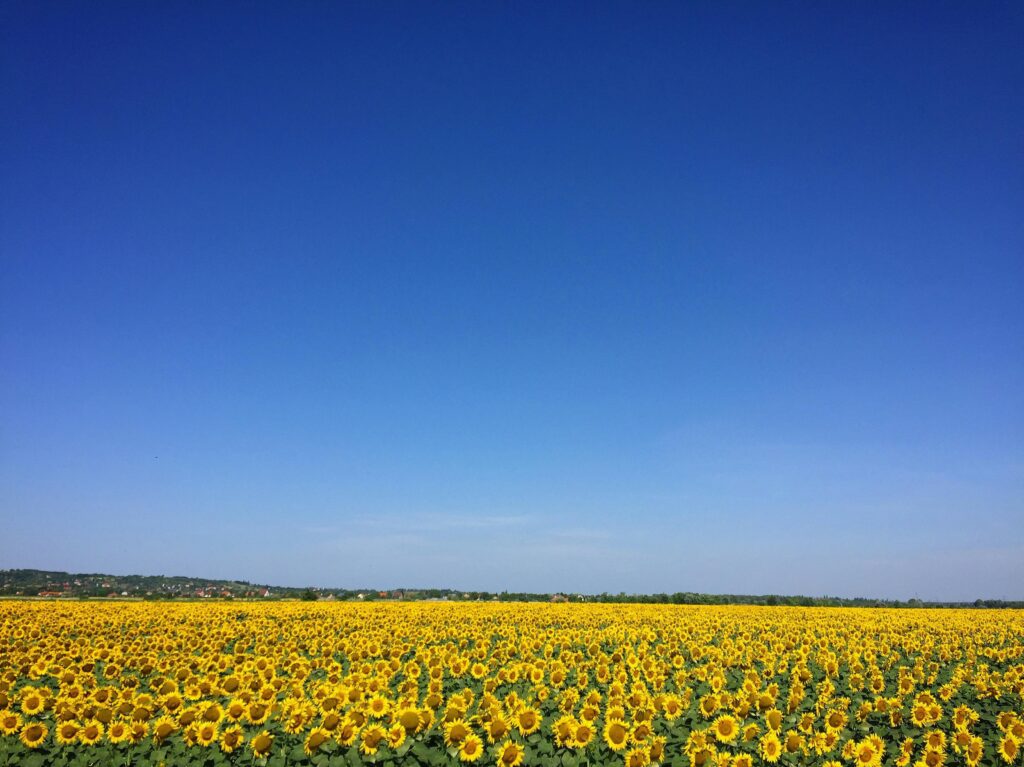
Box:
0, 569, 1024, 608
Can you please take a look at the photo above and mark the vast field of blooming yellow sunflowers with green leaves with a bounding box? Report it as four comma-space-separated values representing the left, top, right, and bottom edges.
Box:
0, 601, 1024, 767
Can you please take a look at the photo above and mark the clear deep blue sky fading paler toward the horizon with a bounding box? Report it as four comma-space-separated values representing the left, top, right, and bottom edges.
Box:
0, 2, 1024, 599
